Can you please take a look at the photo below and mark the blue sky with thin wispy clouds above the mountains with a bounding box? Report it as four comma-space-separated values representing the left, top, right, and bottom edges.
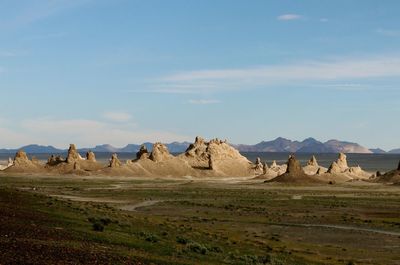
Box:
0, 0, 400, 150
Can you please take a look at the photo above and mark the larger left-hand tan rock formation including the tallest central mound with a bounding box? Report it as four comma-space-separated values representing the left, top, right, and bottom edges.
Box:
2, 137, 252, 177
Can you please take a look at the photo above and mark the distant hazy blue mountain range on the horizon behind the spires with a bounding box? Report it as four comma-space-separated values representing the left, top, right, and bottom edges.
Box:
0, 137, 400, 154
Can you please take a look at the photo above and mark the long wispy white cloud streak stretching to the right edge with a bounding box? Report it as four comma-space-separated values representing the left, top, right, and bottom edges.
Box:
156, 55, 400, 92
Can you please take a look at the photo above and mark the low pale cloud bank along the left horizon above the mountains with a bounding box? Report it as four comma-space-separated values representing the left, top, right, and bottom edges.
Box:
0, 117, 192, 148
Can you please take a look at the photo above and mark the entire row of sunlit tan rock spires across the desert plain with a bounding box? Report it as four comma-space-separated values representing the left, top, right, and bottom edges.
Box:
0, 137, 400, 183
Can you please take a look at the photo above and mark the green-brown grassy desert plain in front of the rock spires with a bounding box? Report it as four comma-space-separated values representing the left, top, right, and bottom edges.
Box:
0, 176, 400, 264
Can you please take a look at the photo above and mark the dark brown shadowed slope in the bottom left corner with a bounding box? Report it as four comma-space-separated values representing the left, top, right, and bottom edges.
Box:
0, 188, 144, 264
